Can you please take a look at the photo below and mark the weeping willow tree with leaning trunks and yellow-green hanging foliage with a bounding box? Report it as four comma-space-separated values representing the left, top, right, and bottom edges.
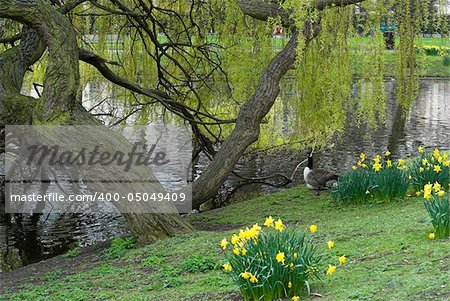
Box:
0, 0, 445, 242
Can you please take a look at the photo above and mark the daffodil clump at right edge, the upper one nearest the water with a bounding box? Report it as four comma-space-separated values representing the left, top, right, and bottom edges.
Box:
410, 146, 450, 195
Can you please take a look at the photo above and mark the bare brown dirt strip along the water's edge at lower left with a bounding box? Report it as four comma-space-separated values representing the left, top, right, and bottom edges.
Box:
0, 243, 109, 293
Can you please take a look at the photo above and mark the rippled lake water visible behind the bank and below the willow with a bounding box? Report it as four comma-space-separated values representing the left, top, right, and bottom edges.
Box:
0, 79, 450, 271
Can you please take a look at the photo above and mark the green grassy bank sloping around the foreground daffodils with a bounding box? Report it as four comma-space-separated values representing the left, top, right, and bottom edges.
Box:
1, 187, 450, 301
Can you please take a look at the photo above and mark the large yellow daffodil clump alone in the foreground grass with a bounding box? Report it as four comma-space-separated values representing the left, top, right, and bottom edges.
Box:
220, 216, 346, 300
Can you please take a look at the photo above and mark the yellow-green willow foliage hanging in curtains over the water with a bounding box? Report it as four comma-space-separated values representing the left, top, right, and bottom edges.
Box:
0, 0, 448, 147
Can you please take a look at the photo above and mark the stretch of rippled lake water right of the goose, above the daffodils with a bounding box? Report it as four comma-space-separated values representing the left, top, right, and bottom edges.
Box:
319, 80, 450, 172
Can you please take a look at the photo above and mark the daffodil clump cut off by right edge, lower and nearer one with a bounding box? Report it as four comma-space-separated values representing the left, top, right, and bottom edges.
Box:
421, 182, 450, 239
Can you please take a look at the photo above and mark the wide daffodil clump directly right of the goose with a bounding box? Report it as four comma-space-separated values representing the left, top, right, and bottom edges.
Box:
332, 151, 409, 203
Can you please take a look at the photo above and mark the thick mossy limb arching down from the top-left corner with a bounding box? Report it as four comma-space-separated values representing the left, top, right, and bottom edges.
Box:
0, 0, 79, 119
